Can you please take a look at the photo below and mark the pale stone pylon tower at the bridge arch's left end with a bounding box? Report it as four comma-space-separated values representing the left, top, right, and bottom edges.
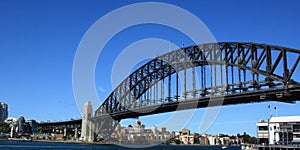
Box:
81, 101, 94, 142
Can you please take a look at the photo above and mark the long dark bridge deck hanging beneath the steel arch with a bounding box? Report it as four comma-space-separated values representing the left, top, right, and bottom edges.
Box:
94, 85, 300, 120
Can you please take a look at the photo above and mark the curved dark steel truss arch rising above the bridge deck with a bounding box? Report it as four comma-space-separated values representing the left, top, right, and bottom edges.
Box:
96, 42, 300, 115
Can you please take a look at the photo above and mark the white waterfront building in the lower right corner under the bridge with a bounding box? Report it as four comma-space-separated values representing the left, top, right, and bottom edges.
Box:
256, 116, 300, 145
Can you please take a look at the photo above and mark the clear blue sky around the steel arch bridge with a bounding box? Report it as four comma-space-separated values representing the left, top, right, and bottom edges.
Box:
0, 0, 300, 135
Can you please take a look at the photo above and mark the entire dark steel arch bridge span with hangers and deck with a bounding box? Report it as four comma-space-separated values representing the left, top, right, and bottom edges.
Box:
92, 42, 300, 140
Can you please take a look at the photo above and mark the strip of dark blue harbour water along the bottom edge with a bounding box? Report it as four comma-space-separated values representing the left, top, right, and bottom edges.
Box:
0, 141, 241, 150
